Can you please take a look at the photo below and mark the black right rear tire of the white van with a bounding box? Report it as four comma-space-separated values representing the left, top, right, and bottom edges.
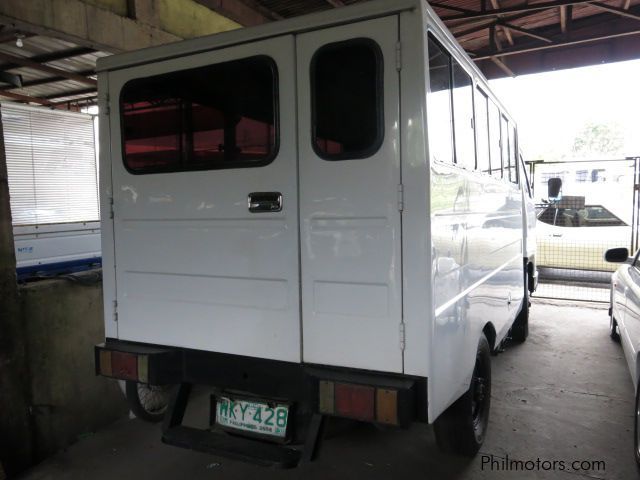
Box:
434, 333, 491, 457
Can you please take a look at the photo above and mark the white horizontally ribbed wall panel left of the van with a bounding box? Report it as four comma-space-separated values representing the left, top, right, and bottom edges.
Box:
1, 103, 99, 225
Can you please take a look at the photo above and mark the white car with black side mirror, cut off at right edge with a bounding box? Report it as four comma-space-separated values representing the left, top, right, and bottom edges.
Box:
605, 248, 640, 467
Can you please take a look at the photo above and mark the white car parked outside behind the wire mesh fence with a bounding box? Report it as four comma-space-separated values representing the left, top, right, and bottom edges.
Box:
536, 205, 631, 272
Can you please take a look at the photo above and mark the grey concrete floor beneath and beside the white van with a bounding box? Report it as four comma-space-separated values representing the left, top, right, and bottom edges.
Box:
17, 300, 637, 480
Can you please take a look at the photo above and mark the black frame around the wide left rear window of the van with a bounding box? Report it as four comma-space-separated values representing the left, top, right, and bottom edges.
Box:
118, 54, 280, 175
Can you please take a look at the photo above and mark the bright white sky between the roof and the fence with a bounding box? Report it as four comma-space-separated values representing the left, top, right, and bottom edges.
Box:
490, 60, 640, 161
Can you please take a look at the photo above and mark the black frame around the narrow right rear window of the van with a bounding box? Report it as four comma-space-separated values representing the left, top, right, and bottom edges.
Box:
309, 37, 385, 162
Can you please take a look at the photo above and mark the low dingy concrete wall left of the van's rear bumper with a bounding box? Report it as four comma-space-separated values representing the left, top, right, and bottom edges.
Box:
19, 275, 128, 462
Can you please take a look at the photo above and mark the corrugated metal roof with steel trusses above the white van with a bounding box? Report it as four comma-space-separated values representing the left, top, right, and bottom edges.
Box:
0, 0, 640, 108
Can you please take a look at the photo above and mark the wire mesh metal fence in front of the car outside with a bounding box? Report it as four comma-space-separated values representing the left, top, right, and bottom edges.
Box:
529, 158, 640, 302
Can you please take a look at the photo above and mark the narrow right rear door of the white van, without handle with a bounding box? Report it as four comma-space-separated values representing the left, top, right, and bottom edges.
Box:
297, 17, 402, 372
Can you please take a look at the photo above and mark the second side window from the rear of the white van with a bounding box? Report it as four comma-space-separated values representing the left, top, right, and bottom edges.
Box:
453, 60, 476, 170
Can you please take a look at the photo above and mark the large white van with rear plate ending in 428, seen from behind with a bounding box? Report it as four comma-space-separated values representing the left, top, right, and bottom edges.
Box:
96, 0, 535, 466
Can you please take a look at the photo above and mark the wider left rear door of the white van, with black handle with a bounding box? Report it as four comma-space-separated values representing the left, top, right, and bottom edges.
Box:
109, 36, 301, 362
